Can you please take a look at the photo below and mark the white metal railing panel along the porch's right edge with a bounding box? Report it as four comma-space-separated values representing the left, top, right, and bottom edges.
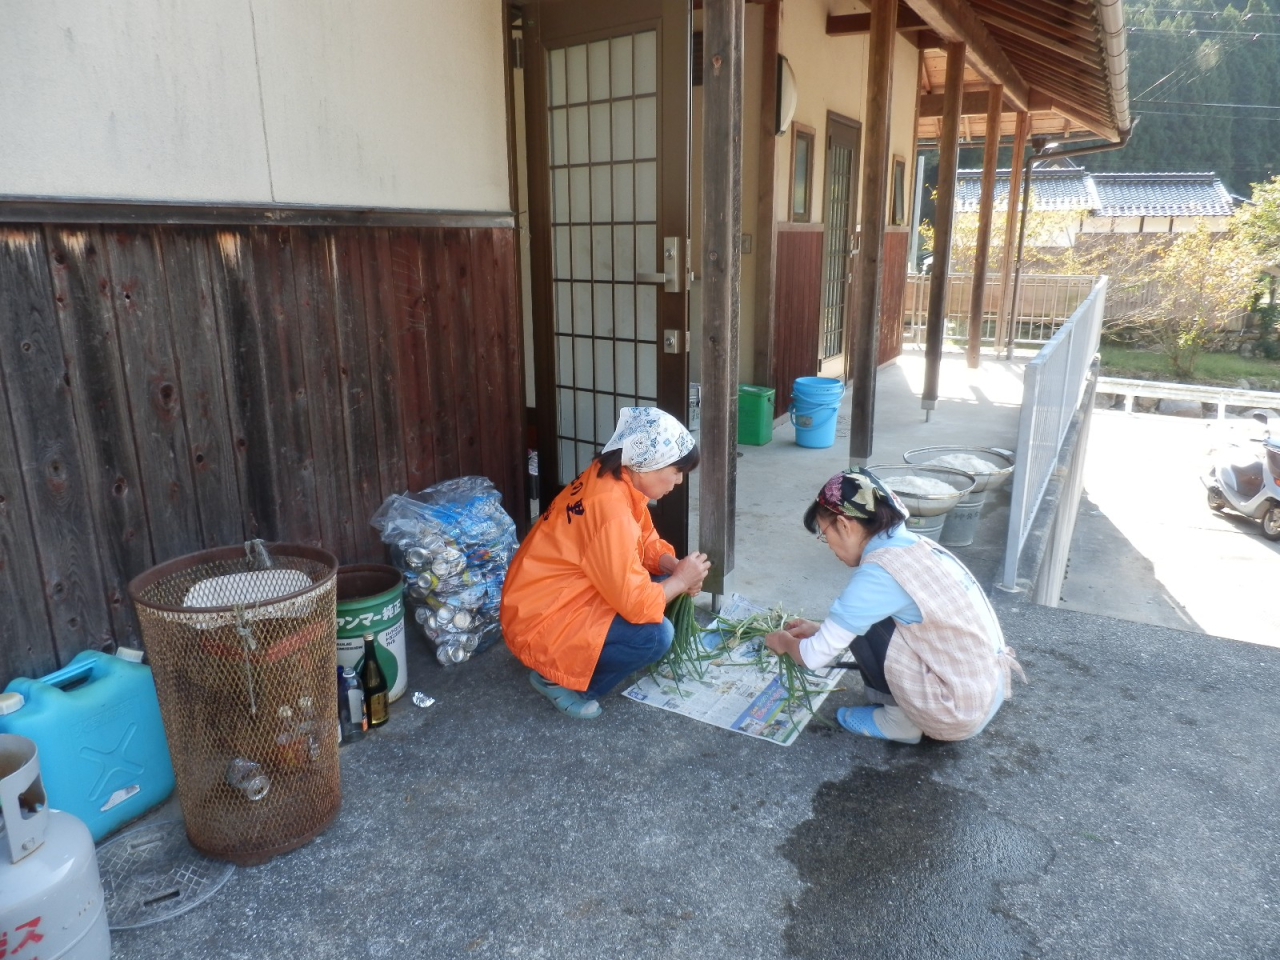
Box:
1002, 276, 1107, 590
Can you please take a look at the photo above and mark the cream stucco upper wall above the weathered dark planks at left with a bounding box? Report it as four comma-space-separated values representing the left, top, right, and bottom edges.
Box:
0, 0, 511, 211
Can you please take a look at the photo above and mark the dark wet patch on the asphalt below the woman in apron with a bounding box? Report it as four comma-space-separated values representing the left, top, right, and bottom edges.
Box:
782, 744, 1052, 960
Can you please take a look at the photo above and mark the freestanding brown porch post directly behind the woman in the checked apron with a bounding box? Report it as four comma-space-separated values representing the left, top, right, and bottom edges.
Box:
849, 0, 897, 467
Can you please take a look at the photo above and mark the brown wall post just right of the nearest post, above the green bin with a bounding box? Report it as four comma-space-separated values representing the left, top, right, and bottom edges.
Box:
751, 0, 782, 387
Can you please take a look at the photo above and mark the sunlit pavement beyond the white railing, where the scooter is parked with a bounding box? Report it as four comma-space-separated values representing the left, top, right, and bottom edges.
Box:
1062, 410, 1280, 645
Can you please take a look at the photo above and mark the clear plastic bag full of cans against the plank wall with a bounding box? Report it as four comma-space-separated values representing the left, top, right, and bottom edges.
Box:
370, 476, 517, 666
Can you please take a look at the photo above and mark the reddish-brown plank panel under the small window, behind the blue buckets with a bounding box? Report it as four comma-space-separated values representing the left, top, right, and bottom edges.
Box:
773, 224, 822, 416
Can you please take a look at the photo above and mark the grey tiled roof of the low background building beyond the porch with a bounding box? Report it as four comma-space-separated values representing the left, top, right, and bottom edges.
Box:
956, 168, 1234, 216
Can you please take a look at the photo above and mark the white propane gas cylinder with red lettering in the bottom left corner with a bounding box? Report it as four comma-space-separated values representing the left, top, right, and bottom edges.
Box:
0, 732, 111, 960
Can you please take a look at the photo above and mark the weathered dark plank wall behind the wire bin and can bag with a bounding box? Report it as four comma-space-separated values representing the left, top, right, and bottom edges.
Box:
0, 224, 527, 685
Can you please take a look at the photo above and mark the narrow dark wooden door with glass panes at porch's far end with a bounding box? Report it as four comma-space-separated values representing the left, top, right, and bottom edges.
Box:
818, 114, 863, 380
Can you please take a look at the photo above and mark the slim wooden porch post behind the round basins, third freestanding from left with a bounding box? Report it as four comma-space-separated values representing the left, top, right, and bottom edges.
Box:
920, 44, 964, 420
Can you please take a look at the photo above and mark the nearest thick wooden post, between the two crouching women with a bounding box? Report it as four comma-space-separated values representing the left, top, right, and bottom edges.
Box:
698, 0, 746, 603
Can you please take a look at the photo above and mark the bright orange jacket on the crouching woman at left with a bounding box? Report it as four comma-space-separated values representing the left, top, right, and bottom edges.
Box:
502, 461, 676, 690
